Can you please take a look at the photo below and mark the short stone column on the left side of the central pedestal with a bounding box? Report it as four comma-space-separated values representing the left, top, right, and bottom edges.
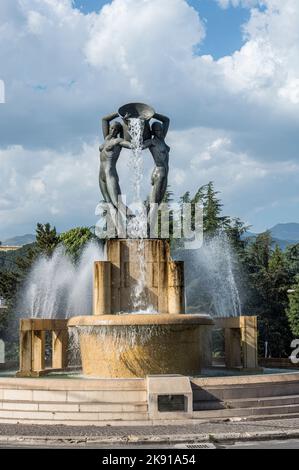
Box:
93, 261, 111, 315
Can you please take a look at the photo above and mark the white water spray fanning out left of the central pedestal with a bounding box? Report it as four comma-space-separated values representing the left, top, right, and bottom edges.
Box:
18, 242, 104, 318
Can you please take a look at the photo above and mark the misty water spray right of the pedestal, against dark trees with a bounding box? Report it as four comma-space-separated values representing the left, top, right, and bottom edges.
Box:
186, 234, 241, 317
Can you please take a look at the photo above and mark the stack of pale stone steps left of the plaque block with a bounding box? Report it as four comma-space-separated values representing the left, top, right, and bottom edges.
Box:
0, 378, 149, 425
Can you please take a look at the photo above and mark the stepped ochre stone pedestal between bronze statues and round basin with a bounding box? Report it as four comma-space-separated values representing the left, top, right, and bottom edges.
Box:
93, 239, 185, 316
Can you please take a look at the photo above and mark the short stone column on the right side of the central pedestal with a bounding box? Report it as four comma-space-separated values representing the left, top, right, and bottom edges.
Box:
168, 261, 185, 315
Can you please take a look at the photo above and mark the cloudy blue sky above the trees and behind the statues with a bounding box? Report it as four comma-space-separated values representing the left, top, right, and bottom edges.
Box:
0, 0, 299, 240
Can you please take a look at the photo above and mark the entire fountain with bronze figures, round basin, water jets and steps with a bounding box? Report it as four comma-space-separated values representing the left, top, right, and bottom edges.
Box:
0, 103, 270, 425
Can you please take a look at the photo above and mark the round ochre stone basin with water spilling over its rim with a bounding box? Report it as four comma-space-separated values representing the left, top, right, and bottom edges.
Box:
68, 314, 213, 378
